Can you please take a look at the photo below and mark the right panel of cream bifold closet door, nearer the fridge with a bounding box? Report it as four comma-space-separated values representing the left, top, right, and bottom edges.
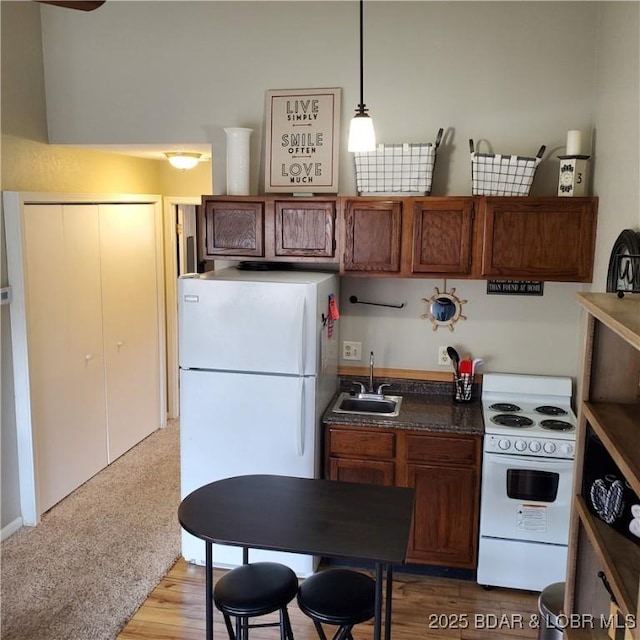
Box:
99, 204, 160, 462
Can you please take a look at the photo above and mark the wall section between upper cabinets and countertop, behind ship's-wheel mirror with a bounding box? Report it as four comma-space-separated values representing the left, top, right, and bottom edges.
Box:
340, 278, 581, 376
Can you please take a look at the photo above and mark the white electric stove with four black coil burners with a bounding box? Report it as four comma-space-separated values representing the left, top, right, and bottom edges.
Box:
477, 373, 576, 591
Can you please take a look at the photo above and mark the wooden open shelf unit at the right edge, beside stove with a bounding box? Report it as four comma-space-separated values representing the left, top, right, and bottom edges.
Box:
564, 293, 640, 640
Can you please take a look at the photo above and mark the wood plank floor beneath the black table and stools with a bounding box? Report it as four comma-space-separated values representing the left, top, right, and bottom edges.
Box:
117, 559, 538, 640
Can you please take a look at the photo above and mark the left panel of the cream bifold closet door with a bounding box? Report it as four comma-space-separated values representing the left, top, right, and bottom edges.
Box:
24, 204, 108, 513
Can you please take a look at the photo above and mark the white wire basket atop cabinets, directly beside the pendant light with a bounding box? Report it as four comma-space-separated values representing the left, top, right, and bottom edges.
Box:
353, 129, 443, 196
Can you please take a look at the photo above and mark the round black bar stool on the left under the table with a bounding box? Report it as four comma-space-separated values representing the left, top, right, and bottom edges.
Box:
213, 562, 298, 640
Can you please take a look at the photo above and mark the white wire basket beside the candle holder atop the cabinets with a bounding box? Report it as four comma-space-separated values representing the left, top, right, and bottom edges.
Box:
469, 140, 546, 196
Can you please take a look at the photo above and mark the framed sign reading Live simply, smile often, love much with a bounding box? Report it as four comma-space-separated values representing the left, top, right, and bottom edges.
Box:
264, 88, 342, 194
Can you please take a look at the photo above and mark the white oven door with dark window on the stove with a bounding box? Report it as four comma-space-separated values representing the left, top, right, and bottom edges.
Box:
480, 453, 574, 545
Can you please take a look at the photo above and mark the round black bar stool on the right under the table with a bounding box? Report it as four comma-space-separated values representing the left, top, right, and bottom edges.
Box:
298, 569, 376, 640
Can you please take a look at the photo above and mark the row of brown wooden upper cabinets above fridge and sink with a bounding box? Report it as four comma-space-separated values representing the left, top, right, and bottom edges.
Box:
198, 196, 598, 282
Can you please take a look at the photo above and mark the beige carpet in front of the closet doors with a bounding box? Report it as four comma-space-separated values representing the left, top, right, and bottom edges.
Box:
0, 422, 180, 640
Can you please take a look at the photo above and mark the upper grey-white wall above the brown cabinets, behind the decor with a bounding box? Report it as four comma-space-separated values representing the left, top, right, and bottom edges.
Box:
42, 1, 598, 195
